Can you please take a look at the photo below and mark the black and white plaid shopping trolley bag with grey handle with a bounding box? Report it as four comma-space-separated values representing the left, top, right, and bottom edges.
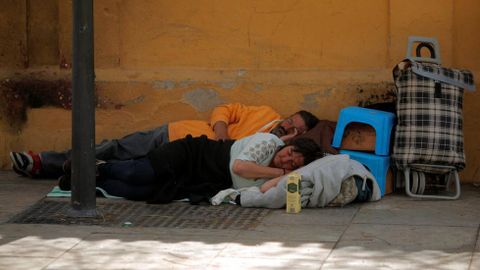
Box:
392, 37, 475, 198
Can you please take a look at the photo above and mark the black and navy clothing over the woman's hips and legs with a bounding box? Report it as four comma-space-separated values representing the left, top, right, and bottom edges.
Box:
97, 136, 233, 203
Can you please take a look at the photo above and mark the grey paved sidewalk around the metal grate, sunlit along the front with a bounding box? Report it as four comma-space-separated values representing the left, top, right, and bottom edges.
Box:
0, 171, 480, 270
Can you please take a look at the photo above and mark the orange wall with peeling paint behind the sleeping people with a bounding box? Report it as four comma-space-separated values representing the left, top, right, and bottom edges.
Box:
0, 0, 480, 182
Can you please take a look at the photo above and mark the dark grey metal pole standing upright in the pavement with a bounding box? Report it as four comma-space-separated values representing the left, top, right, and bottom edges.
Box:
70, 0, 97, 217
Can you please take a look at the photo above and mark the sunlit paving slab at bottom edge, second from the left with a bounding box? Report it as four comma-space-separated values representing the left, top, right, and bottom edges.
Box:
47, 233, 229, 269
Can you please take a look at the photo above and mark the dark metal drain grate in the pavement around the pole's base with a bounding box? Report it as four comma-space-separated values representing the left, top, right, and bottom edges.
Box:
8, 199, 270, 230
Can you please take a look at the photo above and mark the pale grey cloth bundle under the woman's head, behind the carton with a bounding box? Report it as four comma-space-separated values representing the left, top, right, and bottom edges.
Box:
212, 155, 381, 208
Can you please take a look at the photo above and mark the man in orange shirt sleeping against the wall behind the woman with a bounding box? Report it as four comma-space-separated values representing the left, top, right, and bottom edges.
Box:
10, 103, 318, 178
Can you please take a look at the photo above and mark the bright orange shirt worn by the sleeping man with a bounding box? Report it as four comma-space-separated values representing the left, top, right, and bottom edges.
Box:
168, 103, 282, 141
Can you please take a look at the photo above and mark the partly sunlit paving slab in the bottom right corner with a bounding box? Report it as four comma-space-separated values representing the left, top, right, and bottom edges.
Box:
322, 224, 477, 269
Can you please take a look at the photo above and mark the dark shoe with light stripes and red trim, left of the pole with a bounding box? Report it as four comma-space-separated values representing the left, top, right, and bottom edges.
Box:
10, 151, 42, 177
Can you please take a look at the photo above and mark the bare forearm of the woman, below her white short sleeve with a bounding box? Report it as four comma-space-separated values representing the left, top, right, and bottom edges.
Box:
233, 159, 290, 179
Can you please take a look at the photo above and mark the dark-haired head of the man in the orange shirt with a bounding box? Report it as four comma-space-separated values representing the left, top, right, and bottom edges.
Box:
270, 110, 319, 138
